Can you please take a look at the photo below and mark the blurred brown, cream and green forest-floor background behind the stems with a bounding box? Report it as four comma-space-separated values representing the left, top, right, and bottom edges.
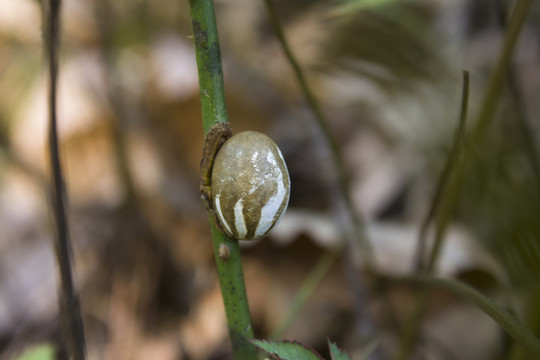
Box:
0, 0, 540, 360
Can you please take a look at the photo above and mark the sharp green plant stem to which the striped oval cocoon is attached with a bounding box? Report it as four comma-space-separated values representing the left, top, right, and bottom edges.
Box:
189, 0, 257, 360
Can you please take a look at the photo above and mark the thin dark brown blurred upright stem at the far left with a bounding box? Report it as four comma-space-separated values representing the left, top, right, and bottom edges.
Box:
45, 0, 86, 360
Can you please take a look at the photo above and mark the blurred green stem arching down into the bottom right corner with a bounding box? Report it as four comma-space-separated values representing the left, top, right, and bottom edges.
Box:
382, 275, 540, 358
